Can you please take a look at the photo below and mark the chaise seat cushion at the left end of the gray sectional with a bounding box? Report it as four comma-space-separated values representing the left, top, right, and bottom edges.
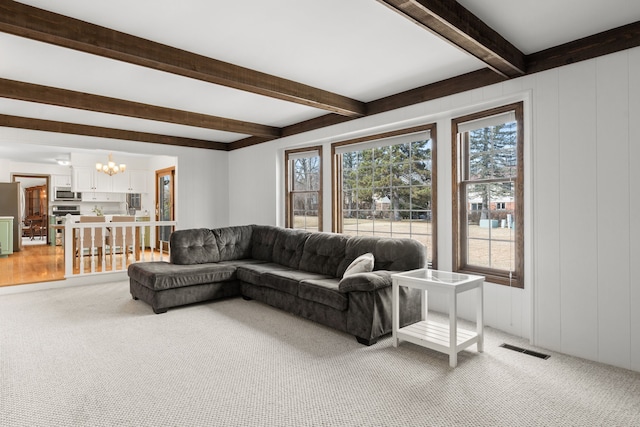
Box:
128, 261, 236, 291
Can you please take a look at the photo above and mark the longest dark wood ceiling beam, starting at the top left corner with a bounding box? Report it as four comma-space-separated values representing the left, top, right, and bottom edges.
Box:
0, 0, 365, 117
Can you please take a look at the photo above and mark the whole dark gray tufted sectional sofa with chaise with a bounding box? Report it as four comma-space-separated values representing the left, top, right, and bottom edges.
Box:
128, 225, 426, 345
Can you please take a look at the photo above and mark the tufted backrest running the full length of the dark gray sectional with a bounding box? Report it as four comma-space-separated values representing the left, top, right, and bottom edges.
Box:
170, 225, 427, 277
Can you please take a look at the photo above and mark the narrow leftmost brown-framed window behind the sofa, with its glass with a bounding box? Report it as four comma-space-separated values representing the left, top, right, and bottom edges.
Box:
285, 147, 322, 231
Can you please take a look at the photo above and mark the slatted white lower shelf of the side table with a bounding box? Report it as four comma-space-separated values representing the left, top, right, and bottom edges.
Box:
397, 320, 478, 354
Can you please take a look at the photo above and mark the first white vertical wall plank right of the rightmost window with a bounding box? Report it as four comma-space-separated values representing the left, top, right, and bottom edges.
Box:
533, 69, 562, 350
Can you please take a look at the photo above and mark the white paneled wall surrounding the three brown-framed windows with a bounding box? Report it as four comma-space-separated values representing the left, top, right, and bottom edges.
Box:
229, 48, 640, 371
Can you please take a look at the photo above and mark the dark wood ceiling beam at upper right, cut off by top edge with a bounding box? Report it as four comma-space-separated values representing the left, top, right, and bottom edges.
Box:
378, 0, 525, 77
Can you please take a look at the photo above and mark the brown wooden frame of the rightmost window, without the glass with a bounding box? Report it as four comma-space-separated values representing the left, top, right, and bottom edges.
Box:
451, 102, 525, 289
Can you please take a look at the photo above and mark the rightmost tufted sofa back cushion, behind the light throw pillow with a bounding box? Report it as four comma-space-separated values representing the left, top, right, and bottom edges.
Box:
338, 236, 427, 277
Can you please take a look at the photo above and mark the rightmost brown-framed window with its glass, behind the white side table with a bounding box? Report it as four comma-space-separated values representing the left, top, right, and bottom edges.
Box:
452, 103, 524, 288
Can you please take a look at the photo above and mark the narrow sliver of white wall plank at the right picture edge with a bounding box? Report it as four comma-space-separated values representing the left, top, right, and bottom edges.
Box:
628, 48, 640, 371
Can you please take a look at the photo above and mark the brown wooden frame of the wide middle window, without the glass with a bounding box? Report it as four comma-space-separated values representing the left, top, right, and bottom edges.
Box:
331, 123, 438, 269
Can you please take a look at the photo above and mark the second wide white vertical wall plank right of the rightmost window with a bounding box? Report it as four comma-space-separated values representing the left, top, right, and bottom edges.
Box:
560, 61, 598, 360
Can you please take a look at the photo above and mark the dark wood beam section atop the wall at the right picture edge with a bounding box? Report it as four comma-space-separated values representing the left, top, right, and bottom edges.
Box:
526, 21, 640, 74
